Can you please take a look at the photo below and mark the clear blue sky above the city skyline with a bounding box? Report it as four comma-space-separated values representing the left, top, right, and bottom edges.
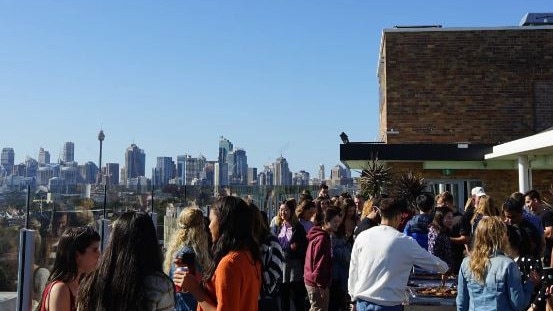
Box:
0, 0, 553, 176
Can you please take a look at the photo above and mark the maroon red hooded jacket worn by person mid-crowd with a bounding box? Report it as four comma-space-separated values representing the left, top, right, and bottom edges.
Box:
303, 226, 332, 288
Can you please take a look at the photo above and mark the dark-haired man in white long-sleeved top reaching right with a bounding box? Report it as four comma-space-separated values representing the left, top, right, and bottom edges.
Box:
348, 198, 449, 311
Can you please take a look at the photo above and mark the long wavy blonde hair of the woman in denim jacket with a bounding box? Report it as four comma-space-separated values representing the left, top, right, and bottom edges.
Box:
469, 216, 509, 284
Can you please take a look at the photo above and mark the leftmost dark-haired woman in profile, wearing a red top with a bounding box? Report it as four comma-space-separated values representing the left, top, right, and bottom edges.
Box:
38, 227, 100, 311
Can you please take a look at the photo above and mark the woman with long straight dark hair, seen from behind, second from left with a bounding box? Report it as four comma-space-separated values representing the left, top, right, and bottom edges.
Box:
78, 212, 175, 311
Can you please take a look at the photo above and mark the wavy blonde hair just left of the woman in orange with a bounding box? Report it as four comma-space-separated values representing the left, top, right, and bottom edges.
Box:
163, 207, 211, 273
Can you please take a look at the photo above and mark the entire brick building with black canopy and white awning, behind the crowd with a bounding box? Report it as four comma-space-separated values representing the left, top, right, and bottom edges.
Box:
340, 20, 553, 210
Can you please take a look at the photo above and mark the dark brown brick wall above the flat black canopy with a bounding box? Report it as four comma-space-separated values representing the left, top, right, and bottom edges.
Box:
379, 27, 553, 144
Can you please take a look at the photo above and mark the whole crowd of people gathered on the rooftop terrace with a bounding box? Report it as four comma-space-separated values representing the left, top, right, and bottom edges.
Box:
31, 185, 553, 311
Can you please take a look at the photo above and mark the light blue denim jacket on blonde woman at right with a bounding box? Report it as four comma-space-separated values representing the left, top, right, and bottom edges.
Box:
457, 253, 534, 311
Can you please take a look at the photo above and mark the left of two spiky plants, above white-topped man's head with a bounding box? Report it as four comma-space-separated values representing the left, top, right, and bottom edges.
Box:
359, 158, 392, 198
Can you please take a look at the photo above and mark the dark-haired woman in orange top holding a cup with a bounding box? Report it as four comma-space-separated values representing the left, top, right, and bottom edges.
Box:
173, 196, 261, 311
